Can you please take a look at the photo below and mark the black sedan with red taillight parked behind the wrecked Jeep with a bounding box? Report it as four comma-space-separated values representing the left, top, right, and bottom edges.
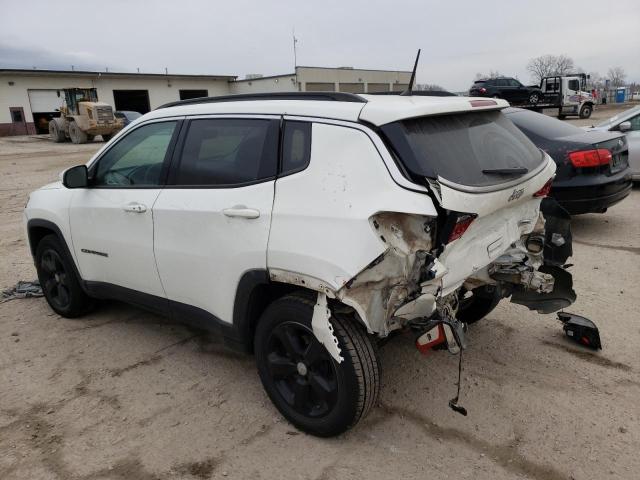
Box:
505, 108, 632, 215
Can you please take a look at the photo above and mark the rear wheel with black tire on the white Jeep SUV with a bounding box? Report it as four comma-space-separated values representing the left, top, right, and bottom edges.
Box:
254, 295, 380, 437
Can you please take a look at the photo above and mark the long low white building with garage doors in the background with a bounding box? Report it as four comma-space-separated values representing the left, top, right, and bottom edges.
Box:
0, 67, 411, 136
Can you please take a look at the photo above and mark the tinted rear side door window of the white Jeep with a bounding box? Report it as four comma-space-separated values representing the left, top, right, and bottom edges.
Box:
171, 118, 279, 187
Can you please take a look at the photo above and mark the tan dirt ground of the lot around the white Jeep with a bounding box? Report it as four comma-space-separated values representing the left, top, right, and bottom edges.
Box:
0, 105, 640, 480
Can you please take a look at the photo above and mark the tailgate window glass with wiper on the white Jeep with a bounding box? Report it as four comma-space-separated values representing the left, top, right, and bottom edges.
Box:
382, 111, 543, 187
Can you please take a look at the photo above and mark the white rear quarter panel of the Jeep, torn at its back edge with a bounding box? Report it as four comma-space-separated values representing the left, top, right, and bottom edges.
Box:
267, 123, 437, 292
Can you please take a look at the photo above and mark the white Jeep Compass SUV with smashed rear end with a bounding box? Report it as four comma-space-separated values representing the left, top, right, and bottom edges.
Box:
24, 92, 575, 436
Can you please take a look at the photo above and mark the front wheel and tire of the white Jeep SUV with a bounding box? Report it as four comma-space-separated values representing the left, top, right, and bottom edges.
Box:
35, 235, 93, 318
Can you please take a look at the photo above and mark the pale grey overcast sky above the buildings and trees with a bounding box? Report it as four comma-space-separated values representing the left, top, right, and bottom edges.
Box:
0, 0, 640, 91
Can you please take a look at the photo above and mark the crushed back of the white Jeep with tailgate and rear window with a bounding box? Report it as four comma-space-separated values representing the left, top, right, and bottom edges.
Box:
368, 100, 575, 332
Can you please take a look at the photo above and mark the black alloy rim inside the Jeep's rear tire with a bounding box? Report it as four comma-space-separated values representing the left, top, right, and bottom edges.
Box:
267, 322, 338, 418
